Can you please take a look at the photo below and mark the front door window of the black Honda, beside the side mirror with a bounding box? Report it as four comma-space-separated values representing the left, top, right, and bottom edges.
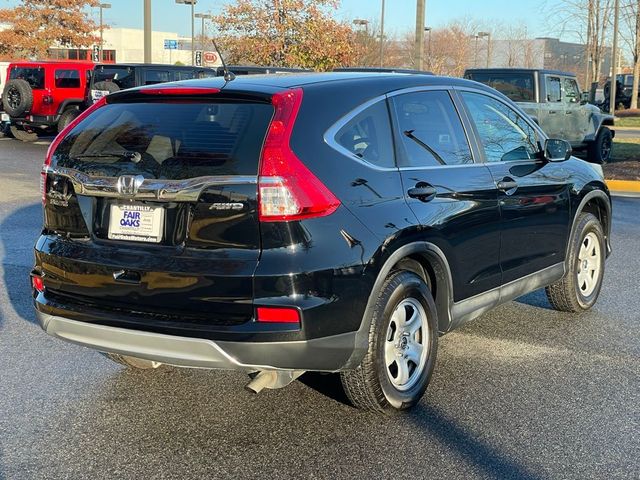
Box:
462, 92, 540, 162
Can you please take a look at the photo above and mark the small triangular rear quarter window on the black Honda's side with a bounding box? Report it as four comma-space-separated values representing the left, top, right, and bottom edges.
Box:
335, 100, 395, 168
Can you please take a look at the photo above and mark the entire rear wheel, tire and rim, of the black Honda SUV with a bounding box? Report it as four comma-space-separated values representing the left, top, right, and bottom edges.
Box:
340, 271, 438, 412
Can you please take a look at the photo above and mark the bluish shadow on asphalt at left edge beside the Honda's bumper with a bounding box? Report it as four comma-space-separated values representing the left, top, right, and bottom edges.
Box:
0, 203, 42, 328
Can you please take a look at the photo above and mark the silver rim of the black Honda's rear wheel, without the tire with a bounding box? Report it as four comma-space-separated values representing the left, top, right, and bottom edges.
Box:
384, 298, 429, 391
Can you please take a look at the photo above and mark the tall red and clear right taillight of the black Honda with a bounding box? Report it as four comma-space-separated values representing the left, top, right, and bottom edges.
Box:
258, 88, 340, 222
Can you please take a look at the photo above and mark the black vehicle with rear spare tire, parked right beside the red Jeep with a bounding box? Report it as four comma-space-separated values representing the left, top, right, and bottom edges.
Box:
90, 63, 218, 103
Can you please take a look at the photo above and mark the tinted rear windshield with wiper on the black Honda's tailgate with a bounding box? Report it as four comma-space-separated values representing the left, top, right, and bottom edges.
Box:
53, 102, 273, 180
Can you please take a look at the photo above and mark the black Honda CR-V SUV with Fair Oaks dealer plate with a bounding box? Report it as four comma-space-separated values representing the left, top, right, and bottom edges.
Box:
32, 73, 611, 410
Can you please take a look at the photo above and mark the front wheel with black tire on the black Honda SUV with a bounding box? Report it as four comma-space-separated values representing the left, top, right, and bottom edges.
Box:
545, 213, 607, 313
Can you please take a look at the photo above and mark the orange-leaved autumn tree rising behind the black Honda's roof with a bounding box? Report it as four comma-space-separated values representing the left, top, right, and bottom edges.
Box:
215, 0, 358, 70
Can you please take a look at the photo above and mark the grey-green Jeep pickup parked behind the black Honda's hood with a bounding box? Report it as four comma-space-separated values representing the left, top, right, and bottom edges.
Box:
464, 68, 615, 164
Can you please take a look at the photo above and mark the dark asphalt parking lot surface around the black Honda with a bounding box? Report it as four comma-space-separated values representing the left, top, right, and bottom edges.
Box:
0, 139, 640, 479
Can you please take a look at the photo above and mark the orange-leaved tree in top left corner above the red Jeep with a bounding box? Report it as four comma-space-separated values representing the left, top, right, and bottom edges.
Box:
0, 0, 98, 58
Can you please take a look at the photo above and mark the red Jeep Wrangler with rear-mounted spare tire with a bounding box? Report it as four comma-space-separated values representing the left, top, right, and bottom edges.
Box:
2, 61, 94, 142
